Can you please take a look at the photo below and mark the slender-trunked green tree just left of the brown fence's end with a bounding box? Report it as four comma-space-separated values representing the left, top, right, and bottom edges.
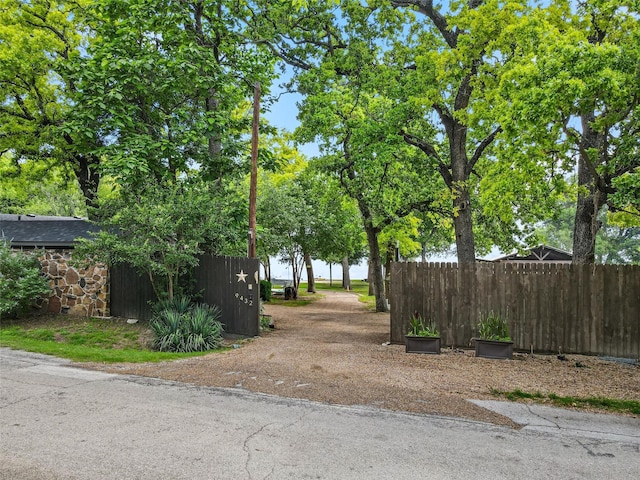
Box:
299, 83, 450, 311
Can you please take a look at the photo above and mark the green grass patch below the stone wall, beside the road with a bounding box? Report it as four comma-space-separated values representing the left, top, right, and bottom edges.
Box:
0, 315, 220, 363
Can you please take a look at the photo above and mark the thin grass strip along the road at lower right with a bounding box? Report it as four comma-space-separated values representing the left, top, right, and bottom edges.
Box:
491, 389, 640, 415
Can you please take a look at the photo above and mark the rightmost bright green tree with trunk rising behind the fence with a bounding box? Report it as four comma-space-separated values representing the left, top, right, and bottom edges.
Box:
496, 0, 640, 263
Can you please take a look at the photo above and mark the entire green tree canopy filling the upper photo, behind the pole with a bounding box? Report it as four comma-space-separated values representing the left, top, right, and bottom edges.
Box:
0, 0, 640, 280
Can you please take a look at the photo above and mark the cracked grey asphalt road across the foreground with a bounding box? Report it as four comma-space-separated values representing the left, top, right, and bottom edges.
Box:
0, 349, 640, 480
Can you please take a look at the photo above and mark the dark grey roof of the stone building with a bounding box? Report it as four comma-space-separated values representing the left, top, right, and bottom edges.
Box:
0, 214, 99, 248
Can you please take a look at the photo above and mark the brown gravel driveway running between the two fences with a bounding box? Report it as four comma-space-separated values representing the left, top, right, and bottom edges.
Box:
84, 291, 640, 426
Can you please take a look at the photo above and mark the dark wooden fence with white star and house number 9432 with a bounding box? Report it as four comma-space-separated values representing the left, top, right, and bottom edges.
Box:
109, 255, 260, 336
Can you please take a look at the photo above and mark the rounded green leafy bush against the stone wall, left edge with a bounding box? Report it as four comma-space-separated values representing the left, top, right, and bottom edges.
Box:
0, 241, 50, 316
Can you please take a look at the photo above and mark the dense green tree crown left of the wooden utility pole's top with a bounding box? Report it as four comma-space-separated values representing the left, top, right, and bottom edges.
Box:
73, 0, 274, 186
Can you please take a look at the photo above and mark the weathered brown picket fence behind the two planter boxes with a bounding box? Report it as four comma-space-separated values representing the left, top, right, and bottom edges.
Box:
390, 262, 640, 359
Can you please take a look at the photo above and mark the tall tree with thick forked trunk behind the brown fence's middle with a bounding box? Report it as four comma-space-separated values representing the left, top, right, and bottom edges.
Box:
252, 0, 550, 272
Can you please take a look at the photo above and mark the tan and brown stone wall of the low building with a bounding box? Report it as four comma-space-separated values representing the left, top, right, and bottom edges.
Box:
39, 250, 109, 317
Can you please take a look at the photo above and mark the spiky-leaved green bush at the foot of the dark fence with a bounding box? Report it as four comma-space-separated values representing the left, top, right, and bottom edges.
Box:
151, 297, 224, 352
